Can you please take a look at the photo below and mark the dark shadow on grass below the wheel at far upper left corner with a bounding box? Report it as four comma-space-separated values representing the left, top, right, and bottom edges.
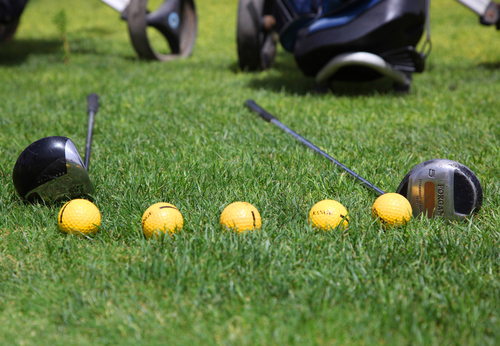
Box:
0, 38, 62, 66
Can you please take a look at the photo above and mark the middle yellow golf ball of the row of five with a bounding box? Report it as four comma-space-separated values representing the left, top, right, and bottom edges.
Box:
220, 202, 262, 233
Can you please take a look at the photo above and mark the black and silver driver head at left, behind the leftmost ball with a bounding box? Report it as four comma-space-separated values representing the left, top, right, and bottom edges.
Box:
12, 136, 94, 203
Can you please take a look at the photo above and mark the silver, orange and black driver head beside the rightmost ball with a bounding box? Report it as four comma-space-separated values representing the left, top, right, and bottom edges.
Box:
396, 159, 483, 220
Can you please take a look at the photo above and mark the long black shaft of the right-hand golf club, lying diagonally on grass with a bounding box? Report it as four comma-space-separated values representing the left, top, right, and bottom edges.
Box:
245, 100, 385, 195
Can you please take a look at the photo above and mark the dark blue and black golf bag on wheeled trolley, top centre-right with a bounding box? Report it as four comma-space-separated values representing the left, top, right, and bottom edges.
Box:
238, 0, 430, 91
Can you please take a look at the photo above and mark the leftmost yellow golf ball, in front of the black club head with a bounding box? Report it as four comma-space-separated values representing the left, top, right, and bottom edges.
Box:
57, 199, 101, 235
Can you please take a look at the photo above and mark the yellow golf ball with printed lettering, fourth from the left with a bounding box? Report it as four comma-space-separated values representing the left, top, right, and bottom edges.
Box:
309, 199, 349, 231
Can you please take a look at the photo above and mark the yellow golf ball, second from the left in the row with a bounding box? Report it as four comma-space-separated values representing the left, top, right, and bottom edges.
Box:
141, 203, 184, 238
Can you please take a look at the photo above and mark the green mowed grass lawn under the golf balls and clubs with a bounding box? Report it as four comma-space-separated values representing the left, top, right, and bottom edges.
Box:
0, 0, 500, 345
